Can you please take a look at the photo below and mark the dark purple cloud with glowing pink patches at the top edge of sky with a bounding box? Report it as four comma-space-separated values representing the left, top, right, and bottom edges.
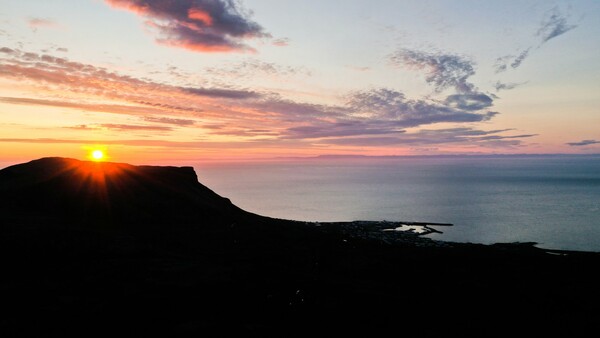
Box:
105, 0, 270, 52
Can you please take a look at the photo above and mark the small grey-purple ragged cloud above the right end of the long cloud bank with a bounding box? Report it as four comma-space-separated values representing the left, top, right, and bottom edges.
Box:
389, 49, 475, 93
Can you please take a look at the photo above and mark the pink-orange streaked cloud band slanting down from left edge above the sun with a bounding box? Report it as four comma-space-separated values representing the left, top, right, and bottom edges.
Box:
0, 49, 261, 118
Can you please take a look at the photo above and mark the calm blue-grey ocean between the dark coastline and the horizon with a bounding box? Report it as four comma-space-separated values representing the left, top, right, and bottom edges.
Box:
194, 155, 600, 252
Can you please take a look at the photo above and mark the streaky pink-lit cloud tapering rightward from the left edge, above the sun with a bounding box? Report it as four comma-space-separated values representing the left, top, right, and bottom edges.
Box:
0, 48, 260, 112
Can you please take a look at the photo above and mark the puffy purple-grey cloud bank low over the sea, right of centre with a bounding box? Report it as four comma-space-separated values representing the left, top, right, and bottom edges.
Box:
281, 88, 497, 142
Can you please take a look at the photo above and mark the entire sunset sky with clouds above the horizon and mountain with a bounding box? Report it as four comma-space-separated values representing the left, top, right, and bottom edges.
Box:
0, 0, 600, 164
